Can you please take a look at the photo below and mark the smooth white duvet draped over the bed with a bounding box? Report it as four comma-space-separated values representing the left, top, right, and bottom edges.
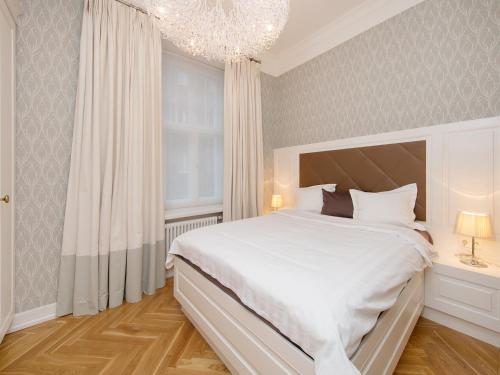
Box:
167, 210, 433, 375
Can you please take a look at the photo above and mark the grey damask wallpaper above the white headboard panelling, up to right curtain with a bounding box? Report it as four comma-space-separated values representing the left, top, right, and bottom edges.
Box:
262, 0, 500, 207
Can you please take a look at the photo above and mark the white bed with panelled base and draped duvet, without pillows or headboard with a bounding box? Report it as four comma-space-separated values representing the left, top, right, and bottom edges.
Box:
167, 210, 433, 375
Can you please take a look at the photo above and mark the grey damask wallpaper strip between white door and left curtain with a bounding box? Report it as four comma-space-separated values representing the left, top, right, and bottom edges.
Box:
16, 0, 83, 312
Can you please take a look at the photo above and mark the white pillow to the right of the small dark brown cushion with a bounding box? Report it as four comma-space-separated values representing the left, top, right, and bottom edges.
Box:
349, 184, 417, 228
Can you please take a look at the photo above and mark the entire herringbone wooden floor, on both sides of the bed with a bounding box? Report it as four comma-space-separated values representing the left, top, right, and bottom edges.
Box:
0, 281, 500, 375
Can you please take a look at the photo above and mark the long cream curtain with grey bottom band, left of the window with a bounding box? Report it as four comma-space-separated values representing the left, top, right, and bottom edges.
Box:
57, 0, 165, 316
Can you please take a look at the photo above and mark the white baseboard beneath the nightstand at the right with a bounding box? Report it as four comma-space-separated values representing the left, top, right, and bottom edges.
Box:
422, 307, 500, 348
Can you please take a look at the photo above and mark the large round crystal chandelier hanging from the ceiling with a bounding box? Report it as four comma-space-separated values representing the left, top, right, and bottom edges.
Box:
140, 0, 289, 62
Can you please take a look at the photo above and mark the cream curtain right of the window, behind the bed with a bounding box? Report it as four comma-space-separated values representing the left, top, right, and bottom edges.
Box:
223, 59, 264, 221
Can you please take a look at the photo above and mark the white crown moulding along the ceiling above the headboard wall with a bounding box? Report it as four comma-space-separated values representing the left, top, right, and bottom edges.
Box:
261, 0, 425, 77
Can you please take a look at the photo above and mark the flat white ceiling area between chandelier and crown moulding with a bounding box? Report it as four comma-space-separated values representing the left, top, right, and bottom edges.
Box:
270, 0, 370, 53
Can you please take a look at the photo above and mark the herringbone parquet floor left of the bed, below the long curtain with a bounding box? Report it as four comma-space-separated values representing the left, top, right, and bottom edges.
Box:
0, 279, 228, 375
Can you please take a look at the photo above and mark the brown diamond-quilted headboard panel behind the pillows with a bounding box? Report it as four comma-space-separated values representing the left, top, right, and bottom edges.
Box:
299, 141, 426, 220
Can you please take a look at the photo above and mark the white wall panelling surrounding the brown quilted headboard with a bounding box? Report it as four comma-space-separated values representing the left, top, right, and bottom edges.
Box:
274, 117, 500, 265
